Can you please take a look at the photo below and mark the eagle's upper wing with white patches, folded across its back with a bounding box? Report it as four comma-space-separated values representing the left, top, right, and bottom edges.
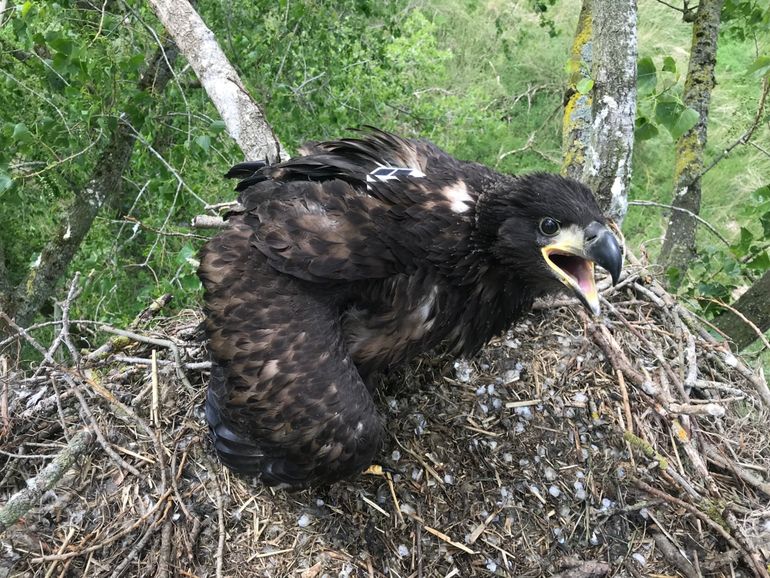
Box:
231, 132, 486, 282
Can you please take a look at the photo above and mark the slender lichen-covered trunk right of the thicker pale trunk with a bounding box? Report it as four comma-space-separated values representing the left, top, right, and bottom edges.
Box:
658, 0, 724, 275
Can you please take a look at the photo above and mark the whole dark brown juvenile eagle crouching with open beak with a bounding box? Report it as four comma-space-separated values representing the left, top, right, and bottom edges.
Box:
198, 131, 621, 487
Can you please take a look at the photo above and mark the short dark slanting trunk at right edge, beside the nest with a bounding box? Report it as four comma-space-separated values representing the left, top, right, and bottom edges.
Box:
714, 271, 770, 351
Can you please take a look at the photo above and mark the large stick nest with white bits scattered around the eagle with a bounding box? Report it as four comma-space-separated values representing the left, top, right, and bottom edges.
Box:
0, 263, 770, 578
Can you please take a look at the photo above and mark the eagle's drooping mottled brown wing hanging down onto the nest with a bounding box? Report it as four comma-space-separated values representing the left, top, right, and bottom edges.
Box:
200, 226, 383, 488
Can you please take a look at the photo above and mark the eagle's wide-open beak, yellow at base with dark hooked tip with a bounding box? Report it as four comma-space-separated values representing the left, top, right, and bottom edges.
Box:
541, 221, 623, 315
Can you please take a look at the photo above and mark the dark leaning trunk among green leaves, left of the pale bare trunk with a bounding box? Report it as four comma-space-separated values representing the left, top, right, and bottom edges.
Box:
9, 46, 176, 327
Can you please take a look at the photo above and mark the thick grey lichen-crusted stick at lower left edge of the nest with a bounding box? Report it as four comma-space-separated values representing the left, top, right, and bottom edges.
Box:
0, 429, 94, 533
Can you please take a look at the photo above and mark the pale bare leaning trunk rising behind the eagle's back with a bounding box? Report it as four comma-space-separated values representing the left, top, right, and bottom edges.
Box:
144, 0, 289, 163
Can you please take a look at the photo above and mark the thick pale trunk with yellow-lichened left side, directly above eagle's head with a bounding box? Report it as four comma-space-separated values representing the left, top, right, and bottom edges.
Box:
563, 0, 637, 224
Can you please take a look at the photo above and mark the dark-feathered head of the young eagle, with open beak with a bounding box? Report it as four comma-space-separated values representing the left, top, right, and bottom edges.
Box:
476, 173, 623, 315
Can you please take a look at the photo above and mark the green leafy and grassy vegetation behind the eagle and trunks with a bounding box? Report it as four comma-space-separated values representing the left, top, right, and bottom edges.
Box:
0, 0, 770, 360
